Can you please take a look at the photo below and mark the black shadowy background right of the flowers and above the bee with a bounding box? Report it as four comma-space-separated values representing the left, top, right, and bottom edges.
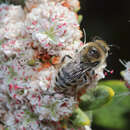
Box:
79, 0, 130, 79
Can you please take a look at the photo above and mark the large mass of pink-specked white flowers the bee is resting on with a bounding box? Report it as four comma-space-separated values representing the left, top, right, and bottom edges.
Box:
0, 0, 104, 130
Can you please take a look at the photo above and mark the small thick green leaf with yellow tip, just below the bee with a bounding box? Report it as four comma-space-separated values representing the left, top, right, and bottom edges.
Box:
79, 85, 114, 111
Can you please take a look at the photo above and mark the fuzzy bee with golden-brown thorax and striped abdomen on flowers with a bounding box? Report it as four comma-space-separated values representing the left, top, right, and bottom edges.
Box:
55, 40, 109, 92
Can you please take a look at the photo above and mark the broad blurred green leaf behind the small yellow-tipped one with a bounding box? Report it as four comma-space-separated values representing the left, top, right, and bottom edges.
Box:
94, 80, 130, 129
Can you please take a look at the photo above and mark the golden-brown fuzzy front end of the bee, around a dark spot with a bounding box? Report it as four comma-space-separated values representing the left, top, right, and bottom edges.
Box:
80, 40, 109, 67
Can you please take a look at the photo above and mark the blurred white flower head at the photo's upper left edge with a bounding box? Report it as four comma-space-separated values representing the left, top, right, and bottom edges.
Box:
0, 4, 25, 40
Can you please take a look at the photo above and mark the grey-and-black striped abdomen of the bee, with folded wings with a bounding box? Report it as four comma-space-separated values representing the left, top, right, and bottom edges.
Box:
55, 62, 88, 92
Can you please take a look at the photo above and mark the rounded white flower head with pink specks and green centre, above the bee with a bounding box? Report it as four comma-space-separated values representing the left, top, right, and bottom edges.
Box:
25, 2, 81, 54
